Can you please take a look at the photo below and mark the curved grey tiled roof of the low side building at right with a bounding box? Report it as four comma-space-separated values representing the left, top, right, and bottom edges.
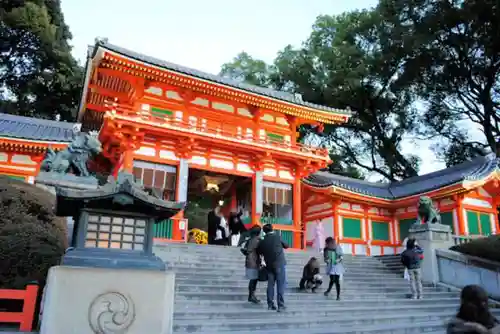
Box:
304, 156, 500, 199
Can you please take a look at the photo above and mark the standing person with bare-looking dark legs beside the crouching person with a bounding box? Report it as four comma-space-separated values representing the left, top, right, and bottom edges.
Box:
323, 237, 345, 300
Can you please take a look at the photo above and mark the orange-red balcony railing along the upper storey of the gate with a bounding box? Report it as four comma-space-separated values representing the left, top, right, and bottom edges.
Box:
105, 106, 329, 158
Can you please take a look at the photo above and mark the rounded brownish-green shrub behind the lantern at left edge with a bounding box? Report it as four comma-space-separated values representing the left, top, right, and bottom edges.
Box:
0, 175, 67, 288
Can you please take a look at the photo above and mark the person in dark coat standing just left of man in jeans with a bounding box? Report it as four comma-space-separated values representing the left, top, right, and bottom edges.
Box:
241, 225, 261, 304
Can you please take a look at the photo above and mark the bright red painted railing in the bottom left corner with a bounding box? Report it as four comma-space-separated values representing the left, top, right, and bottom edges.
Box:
0, 285, 38, 331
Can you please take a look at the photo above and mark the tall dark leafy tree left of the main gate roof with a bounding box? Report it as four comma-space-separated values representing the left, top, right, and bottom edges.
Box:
0, 0, 82, 120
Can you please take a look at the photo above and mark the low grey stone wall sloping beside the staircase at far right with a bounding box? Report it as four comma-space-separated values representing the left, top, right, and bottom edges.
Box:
436, 249, 500, 300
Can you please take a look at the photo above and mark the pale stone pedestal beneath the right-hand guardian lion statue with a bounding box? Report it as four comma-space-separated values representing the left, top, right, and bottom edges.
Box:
410, 224, 453, 284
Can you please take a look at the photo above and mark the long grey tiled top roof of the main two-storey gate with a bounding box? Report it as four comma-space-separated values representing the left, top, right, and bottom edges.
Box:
94, 41, 350, 115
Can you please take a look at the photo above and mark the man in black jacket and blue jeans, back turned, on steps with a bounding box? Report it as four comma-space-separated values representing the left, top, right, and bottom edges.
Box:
257, 224, 288, 312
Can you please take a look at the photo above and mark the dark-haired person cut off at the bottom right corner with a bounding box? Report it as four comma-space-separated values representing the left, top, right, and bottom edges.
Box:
446, 285, 500, 334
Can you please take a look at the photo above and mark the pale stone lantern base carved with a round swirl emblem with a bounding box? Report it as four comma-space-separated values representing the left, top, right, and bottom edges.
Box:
40, 266, 175, 334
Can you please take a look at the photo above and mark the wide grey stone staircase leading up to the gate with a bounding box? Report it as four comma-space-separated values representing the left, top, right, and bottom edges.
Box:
154, 244, 500, 334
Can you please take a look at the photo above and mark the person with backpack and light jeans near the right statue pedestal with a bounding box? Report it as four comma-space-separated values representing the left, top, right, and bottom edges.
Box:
401, 238, 424, 299
